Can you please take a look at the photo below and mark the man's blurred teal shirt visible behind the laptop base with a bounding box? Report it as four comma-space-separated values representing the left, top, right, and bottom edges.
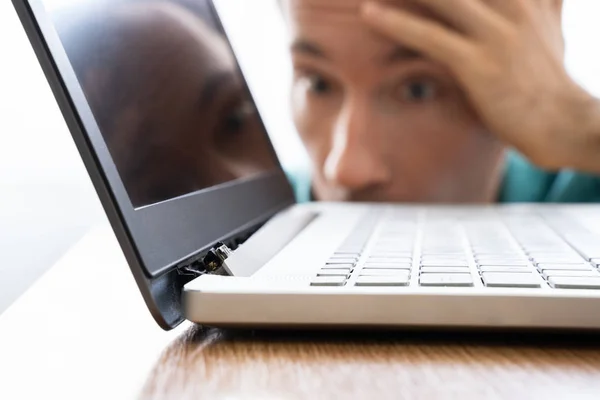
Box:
288, 152, 600, 203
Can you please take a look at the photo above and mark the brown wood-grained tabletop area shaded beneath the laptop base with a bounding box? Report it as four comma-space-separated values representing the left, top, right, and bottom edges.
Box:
141, 327, 600, 399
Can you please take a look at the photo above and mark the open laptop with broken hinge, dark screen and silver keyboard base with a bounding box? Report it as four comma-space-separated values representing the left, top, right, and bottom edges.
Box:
13, 0, 600, 330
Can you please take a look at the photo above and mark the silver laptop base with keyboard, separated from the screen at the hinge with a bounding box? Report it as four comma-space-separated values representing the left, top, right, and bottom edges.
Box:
185, 204, 600, 329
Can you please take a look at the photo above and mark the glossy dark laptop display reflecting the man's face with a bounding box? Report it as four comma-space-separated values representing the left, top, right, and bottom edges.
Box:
49, 0, 276, 207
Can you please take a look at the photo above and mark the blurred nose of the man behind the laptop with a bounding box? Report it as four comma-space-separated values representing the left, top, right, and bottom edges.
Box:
324, 97, 391, 190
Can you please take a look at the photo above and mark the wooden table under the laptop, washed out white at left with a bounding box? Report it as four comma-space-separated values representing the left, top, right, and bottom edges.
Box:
0, 226, 600, 399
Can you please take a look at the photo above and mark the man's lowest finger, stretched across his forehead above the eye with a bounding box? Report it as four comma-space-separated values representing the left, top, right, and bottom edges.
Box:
362, 2, 473, 69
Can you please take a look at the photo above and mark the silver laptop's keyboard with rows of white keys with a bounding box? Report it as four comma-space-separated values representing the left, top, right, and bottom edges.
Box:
311, 210, 600, 290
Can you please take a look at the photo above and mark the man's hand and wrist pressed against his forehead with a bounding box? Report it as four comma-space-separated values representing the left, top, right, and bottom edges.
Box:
363, 0, 600, 172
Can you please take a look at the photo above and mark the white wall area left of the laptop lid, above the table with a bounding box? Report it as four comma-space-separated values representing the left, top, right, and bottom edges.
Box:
0, 0, 103, 313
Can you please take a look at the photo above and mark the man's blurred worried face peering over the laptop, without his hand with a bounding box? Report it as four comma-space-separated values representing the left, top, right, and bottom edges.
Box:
284, 0, 503, 202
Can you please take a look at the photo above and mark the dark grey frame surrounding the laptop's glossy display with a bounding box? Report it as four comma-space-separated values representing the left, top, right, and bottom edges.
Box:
13, 0, 295, 328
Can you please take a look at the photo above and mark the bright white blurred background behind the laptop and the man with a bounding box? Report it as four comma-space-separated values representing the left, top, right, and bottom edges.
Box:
0, 0, 600, 313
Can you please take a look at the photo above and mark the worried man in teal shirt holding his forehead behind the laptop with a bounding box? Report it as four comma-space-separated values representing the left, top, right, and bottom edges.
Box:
283, 0, 600, 203
